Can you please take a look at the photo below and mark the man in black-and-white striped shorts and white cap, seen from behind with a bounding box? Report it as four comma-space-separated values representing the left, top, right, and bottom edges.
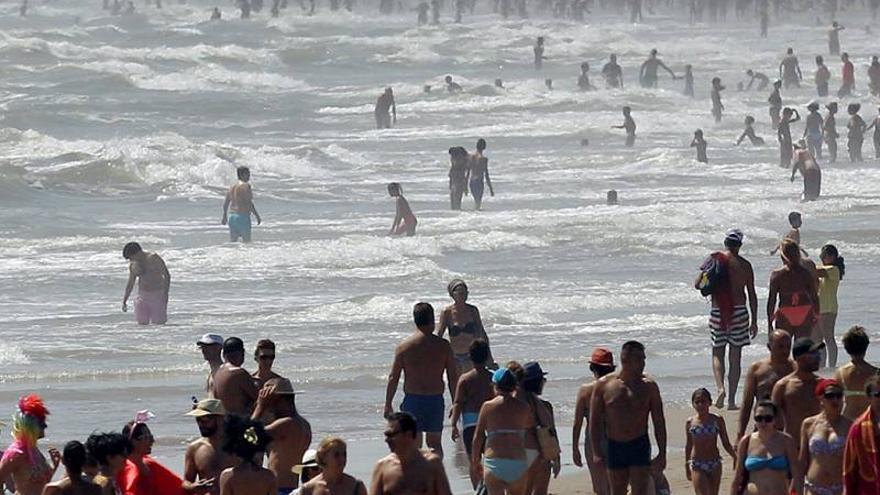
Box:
709, 229, 758, 410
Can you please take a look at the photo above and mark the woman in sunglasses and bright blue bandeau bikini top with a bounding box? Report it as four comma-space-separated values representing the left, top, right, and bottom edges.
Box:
730, 400, 801, 495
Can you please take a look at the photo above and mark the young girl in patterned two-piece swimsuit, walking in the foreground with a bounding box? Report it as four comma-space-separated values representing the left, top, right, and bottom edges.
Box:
684, 388, 736, 495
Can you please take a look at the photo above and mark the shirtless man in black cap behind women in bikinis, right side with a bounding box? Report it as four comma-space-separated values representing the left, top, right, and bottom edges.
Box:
771, 337, 825, 450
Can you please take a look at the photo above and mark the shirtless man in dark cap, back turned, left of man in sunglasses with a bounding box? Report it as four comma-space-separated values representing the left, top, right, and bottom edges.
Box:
214, 337, 259, 416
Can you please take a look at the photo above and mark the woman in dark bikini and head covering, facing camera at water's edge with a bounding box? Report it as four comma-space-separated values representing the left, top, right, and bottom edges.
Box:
437, 278, 497, 373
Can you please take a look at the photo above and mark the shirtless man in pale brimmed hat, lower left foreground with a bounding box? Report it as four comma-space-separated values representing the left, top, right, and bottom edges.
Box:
183, 399, 233, 495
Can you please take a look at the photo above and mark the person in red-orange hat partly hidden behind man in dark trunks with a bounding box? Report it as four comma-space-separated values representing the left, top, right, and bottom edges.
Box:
571, 347, 615, 495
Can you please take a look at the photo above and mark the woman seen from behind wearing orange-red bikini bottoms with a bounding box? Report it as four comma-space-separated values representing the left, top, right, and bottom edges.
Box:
767, 239, 819, 339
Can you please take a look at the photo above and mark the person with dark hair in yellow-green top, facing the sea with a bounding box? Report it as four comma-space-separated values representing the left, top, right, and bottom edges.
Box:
813, 244, 845, 368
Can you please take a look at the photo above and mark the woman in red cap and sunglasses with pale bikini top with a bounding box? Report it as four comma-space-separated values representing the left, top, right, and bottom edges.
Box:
800, 379, 852, 495
